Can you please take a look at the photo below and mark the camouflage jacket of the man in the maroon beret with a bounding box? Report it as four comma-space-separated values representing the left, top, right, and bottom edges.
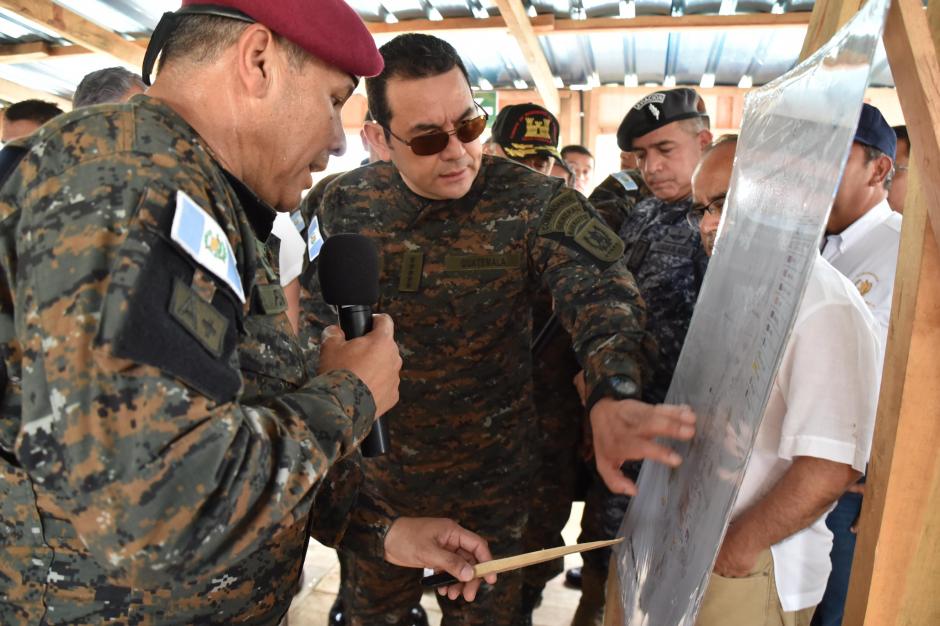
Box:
0, 96, 375, 625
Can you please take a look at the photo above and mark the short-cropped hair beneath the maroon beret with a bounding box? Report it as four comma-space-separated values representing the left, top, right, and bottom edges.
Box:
157, 15, 310, 73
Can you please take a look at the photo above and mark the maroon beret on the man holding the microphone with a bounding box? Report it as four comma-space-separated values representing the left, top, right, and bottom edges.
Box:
176, 0, 384, 77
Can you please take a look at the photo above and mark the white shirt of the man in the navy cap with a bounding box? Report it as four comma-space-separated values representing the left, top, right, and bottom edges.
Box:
822, 200, 901, 343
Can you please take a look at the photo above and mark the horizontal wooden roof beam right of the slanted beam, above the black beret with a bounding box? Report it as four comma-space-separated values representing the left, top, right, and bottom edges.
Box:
545, 12, 810, 35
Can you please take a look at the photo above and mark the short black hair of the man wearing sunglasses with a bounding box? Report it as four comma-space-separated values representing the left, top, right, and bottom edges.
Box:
366, 33, 470, 133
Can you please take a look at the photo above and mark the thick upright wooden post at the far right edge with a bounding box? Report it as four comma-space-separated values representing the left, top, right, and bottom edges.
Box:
844, 0, 940, 626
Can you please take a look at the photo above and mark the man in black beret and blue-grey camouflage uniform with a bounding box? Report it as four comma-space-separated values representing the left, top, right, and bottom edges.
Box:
573, 88, 711, 626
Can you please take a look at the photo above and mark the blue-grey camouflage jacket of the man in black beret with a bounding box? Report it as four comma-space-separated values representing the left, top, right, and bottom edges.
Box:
620, 196, 708, 403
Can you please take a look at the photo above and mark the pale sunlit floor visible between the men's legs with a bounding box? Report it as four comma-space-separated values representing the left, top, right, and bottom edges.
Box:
288, 503, 583, 626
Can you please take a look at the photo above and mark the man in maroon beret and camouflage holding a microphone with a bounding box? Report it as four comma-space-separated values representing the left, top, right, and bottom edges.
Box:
0, 0, 489, 626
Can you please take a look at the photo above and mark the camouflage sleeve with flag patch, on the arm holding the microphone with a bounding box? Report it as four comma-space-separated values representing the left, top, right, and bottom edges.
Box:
0, 153, 375, 585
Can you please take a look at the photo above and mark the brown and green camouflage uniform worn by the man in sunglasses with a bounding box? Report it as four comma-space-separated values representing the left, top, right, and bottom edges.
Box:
300, 157, 651, 624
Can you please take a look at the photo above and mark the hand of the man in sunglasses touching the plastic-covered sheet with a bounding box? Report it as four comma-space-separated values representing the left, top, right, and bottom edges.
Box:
591, 398, 695, 496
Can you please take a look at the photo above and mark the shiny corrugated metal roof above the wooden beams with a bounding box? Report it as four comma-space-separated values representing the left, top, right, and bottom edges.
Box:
0, 0, 893, 98
